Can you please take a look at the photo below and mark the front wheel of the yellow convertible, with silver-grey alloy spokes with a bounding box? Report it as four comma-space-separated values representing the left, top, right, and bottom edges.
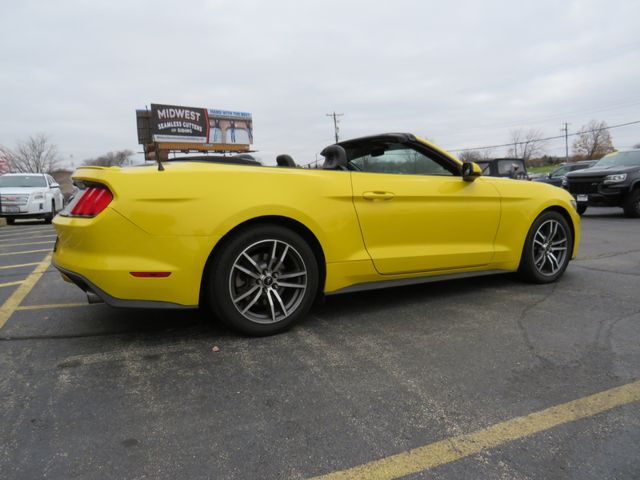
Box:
518, 211, 573, 283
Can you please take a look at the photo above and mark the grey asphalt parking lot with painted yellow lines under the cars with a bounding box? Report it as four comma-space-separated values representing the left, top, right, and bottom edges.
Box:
0, 209, 640, 479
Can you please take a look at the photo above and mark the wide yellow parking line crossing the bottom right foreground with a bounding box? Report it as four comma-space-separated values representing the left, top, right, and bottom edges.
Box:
314, 381, 640, 480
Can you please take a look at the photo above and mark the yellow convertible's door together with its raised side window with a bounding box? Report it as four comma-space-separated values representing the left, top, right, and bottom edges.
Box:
350, 144, 500, 274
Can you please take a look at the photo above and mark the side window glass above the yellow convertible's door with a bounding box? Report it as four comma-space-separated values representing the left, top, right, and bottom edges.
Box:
351, 145, 453, 176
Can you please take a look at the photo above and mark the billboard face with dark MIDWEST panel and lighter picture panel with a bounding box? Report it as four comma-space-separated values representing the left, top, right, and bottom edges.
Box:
149, 103, 253, 146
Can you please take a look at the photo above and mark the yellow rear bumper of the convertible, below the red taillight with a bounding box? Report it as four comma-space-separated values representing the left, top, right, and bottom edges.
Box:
53, 208, 214, 308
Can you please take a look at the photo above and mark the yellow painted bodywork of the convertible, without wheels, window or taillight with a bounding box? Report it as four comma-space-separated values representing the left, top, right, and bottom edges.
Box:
53, 140, 580, 307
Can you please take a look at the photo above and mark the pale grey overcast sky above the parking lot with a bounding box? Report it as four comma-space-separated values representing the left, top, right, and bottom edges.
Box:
0, 0, 640, 164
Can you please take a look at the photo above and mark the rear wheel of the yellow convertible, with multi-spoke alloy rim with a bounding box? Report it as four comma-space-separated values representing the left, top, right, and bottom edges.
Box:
206, 225, 319, 335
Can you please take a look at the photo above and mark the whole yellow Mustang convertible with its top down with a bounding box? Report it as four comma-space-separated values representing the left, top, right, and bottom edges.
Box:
53, 133, 580, 335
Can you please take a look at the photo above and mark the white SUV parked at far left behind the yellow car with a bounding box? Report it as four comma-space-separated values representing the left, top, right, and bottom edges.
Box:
0, 173, 64, 225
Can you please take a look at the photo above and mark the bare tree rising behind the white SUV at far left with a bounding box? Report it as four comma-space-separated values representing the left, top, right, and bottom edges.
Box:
5, 133, 60, 173
